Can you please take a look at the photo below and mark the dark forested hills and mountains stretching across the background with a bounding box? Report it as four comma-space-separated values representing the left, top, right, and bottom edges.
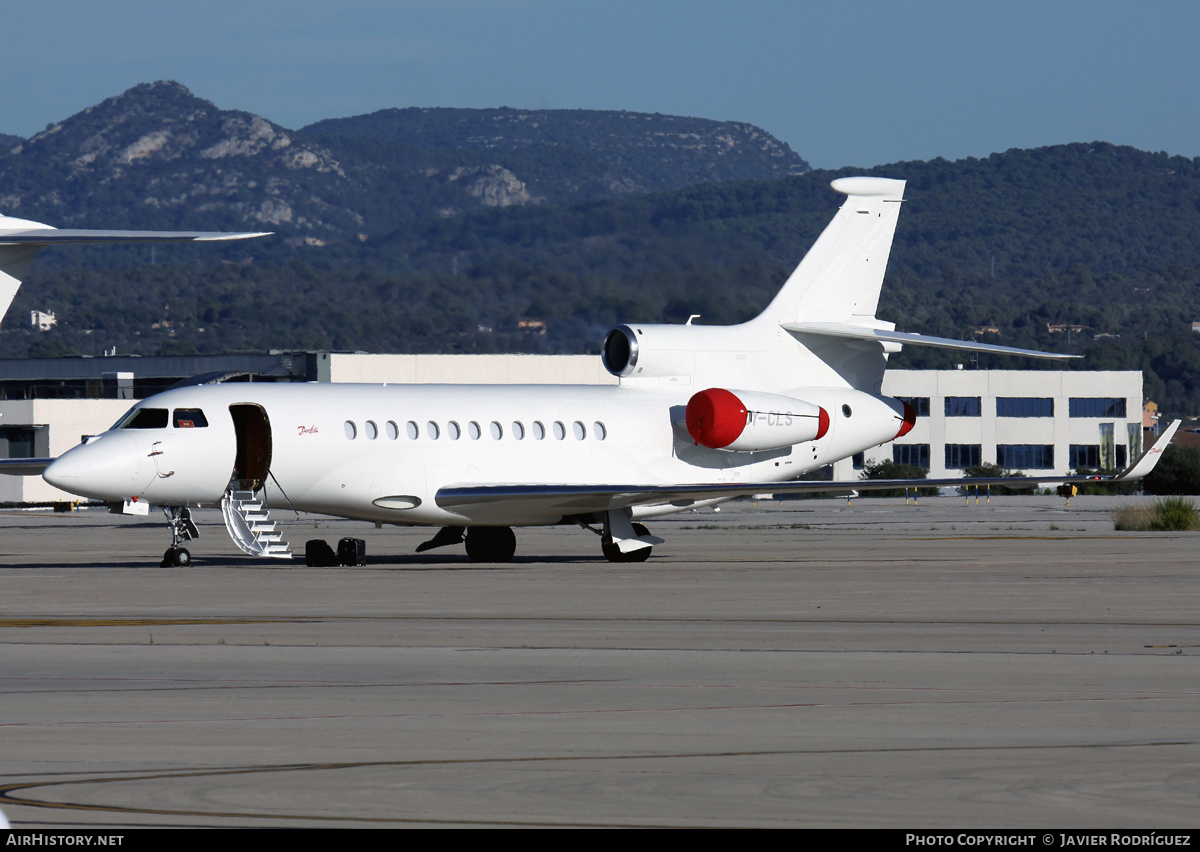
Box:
0, 84, 1200, 413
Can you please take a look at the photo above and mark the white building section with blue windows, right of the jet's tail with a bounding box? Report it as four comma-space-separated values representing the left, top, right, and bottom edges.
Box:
834, 370, 1142, 480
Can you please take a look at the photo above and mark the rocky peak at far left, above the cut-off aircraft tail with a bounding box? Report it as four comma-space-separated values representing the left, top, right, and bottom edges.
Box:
0, 82, 352, 232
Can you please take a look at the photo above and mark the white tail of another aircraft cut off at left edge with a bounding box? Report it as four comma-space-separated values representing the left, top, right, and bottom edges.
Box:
0, 216, 266, 319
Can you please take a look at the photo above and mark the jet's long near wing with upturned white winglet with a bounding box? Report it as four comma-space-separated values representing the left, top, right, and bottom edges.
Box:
434, 420, 1180, 515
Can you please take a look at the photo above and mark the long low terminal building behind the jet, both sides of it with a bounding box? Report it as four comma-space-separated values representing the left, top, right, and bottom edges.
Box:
0, 352, 1142, 504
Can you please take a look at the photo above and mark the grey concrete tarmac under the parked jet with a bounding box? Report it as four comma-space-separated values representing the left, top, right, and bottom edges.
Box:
0, 497, 1200, 829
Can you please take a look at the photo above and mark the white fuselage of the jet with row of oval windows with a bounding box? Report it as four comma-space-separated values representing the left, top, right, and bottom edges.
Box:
44, 383, 904, 526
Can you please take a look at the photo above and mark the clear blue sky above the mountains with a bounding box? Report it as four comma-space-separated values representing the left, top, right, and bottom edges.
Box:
0, 0, 1200, 168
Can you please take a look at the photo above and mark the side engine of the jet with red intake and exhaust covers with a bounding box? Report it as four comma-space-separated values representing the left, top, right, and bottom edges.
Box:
684, 388, 829, 452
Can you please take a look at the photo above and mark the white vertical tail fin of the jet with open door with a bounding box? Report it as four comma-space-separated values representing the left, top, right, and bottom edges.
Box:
762, 178, 905, 328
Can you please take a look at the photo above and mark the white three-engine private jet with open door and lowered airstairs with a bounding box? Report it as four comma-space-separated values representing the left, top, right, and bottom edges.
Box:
21, 176, 1169, 565
